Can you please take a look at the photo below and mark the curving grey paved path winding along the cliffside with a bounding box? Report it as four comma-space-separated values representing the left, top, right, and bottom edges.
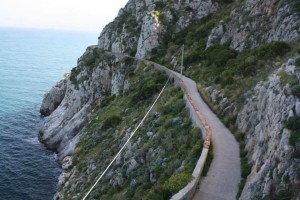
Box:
144, 61, 241, 200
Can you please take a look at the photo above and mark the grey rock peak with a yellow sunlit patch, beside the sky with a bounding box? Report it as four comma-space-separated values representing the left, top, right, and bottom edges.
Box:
98, 0, 217, 58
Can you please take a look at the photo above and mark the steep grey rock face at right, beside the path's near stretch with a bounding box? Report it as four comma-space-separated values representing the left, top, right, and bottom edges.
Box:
237, 60, 300, 199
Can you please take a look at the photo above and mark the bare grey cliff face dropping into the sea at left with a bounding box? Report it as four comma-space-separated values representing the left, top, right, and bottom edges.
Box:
39, 47, 129, 160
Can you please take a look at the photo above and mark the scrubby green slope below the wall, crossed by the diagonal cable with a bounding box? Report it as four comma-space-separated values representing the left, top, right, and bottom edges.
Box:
64, 63, 203, 200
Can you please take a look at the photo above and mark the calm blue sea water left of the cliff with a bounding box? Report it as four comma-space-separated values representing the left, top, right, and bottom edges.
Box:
0, 28, 97, 200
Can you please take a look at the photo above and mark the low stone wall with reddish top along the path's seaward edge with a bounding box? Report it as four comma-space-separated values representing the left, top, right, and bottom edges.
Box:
142, 60, 212, 200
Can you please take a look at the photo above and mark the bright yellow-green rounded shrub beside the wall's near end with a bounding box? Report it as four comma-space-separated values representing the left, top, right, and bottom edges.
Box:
163, 173, 192, 193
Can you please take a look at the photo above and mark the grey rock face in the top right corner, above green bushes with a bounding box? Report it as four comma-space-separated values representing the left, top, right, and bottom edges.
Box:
207, 0, 300, 51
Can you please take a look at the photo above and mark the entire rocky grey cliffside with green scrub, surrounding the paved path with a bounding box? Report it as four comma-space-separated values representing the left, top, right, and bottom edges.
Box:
40, 0, 300, 199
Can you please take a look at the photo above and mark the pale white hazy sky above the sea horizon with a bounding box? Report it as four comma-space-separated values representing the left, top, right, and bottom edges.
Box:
0, 0, 128, 32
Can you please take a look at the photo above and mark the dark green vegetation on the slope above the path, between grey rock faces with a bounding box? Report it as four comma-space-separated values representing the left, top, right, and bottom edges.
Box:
151, 6, 300, 195
